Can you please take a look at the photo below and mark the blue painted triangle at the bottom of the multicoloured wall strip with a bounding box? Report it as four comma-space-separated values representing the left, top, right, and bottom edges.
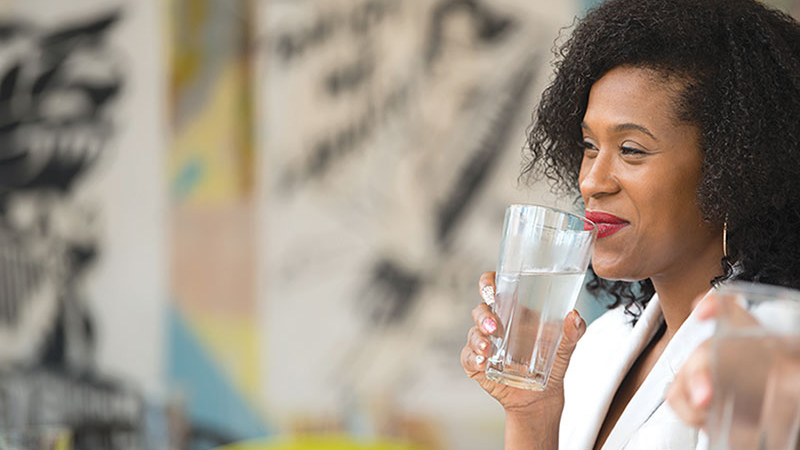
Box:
167, 305, 272, 448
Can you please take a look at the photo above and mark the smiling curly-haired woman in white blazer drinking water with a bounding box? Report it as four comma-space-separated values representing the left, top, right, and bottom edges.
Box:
461, 0, 800, 450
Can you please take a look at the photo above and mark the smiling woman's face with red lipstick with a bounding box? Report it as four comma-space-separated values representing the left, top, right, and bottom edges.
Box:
579, 66, 722, 280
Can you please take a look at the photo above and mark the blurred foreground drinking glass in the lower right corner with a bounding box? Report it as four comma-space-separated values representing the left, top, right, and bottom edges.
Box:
707, 283, 800, 450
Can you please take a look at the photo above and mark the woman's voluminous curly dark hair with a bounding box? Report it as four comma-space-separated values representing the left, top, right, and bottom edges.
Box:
523, 0, 800, 321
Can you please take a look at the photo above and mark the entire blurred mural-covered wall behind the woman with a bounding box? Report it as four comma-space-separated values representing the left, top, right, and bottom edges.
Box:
0, 0, 800, 450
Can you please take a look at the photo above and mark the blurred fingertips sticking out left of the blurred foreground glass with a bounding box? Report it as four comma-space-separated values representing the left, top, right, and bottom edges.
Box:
666, 341, 712, 427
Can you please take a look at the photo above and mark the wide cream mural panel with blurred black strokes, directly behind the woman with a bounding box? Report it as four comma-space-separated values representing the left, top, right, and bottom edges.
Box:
260, 0, 580, 448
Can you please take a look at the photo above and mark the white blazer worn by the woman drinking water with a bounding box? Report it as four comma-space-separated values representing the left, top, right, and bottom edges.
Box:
559, 295, 714, 450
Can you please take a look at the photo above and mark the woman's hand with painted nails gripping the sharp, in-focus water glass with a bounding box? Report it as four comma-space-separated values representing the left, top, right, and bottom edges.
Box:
461, 272, 586, 414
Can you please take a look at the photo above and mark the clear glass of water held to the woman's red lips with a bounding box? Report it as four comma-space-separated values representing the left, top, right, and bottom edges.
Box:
486, 205, 597, 391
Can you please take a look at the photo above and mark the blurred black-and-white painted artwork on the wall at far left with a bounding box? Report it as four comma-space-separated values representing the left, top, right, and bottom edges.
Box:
0, 10, 143, 449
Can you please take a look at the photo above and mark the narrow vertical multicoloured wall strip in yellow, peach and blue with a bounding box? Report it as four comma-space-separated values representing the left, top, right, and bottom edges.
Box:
167, 0, 268, 448
